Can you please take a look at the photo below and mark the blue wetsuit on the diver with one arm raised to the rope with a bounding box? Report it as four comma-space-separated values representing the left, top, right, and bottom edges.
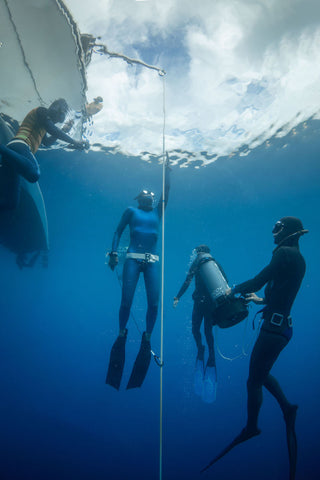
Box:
112, 167, 170, 334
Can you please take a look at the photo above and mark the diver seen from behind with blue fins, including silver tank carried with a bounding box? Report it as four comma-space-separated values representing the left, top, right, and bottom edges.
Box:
173, 245, 247, 403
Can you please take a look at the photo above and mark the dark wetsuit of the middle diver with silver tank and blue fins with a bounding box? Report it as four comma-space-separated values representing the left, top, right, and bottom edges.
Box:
176, 255, 226, 367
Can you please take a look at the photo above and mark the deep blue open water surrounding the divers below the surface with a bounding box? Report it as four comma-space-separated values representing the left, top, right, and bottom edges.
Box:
0, 121, 320, 480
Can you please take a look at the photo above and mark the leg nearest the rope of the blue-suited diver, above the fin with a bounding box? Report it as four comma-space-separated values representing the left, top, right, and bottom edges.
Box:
143, 262, 160, 339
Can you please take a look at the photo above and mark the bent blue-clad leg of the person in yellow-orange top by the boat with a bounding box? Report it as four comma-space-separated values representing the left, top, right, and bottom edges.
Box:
1, 142, 40, 183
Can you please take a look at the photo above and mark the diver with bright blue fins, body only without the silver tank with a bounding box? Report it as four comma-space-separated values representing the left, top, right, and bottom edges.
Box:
173, 245, 227, 403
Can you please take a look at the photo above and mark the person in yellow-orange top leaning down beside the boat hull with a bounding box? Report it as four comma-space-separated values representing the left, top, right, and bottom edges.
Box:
0, 98, 87, 210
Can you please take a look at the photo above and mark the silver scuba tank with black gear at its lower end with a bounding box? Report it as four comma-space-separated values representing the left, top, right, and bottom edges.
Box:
199, 253, 249, 328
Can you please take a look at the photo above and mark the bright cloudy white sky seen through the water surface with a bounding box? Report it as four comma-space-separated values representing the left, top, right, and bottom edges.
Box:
67, 0, 320, 163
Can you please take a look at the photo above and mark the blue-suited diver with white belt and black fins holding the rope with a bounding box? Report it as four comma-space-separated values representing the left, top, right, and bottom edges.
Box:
106, 154, 171, 390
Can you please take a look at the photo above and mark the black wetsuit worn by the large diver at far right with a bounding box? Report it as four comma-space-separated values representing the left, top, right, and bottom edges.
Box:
233, 242, 306, 430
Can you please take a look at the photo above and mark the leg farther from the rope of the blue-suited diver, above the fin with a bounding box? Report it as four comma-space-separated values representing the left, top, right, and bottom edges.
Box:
119, 258, 140, 332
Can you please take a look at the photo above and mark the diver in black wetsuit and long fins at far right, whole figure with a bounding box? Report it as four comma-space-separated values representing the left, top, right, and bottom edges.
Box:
202, 217, 308, 480
